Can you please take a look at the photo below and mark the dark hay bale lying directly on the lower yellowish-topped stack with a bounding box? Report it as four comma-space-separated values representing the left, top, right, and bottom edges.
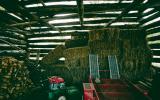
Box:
65, 39, 88, 48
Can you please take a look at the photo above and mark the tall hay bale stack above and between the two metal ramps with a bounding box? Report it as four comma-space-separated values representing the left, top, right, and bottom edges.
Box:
89, 28, 120, 78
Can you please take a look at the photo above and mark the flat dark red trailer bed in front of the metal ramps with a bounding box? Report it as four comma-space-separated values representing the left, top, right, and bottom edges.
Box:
85, 79, 150, 100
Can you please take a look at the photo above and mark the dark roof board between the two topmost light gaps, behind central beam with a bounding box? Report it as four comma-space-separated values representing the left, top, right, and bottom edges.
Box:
28, 3, 130, 14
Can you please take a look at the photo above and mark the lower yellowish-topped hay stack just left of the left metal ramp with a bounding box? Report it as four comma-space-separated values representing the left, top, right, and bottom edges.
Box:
64, 47, 89, 83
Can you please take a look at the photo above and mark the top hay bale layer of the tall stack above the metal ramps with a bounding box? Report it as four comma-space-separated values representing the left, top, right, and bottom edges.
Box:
89, 28, 120, 41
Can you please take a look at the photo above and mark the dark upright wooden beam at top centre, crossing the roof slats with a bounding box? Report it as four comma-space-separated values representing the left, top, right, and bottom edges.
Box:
76, 0, 84, 26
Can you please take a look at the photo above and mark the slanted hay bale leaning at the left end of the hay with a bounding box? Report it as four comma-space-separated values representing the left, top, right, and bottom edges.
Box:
41, 45, 66, 65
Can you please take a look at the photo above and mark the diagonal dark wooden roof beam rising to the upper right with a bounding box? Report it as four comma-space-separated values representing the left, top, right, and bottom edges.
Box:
105, 0, 144, 27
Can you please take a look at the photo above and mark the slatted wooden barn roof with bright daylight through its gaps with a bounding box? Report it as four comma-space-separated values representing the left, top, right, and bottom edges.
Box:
0, 0, 160, 60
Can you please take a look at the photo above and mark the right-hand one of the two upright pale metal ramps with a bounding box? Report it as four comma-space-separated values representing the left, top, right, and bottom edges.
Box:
108, 55, 120, 79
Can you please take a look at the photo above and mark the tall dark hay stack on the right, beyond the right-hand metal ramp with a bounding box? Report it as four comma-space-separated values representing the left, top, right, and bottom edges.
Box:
120, 30, 151, 81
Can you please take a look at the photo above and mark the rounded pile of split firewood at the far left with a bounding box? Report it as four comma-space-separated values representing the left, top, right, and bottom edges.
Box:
0, 57, 32, 100
